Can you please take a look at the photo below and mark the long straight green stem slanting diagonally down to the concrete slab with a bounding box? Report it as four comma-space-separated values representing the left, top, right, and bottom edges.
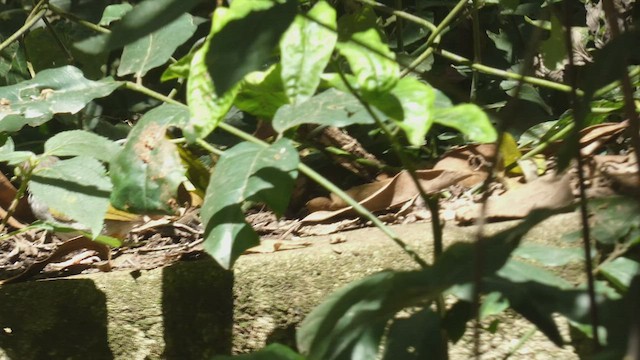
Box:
123, 81, 428, 267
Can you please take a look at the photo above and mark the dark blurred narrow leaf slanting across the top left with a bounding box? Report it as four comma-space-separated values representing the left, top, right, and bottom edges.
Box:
75, 0, 200, 54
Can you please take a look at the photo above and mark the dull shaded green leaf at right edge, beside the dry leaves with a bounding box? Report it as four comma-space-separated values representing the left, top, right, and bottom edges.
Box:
589, 197, 640, 245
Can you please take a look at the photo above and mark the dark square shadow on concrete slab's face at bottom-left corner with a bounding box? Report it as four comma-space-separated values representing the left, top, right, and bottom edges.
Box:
0, 279, 113, 359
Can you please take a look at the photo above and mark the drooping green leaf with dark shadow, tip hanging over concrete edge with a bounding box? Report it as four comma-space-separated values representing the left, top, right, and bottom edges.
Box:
200, 139, 298, 269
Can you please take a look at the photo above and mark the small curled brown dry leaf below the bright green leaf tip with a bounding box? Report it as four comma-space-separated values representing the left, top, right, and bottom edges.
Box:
433, 144, 496, 187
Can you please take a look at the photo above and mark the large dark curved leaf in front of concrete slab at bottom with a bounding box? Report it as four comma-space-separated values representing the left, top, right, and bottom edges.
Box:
297, 211, 550, 360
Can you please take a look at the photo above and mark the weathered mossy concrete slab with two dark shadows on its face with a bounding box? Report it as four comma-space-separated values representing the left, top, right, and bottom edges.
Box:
0, 214, 578, 360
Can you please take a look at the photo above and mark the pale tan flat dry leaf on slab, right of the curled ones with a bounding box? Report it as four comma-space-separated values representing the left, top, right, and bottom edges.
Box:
456, 175, 574, 224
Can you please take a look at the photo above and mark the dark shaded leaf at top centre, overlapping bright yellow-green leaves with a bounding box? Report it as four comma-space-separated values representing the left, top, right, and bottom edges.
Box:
205, 0, 298, 96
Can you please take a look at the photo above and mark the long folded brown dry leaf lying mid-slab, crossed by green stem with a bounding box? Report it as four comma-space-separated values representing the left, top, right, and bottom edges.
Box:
302, 169, 470, 222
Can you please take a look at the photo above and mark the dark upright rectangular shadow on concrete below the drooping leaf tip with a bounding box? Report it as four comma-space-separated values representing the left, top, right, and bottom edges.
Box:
162, 258, 233, 360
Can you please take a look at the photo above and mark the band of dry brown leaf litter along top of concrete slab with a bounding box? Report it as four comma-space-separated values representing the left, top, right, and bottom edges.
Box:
0, 124, 640, 281
